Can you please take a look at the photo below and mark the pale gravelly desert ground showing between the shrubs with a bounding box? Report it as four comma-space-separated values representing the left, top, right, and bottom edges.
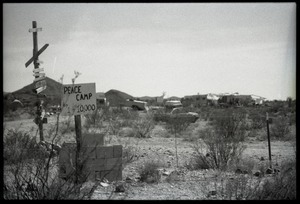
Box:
4, 107, 296, 200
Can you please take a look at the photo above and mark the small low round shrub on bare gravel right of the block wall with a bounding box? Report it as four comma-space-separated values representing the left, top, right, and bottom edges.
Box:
139, 159, 164, 183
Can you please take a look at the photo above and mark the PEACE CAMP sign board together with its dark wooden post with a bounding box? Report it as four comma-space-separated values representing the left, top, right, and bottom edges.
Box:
61, 83, 97, 183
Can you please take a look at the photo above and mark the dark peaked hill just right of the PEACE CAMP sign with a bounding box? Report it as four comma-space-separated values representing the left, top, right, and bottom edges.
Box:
105, 89, 135, 106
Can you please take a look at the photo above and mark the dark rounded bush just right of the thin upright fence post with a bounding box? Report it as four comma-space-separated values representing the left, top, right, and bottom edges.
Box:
269, 116, 290, 139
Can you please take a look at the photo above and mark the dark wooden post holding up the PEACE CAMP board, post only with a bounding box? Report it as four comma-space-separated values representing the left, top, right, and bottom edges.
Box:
74, 115, 82, 184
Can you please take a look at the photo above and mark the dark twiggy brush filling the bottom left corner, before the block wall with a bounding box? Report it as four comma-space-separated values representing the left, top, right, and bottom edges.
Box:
3, 116, 96, 199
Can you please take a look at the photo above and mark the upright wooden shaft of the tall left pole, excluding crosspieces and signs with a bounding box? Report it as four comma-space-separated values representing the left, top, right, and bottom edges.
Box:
32, 21, 44, 141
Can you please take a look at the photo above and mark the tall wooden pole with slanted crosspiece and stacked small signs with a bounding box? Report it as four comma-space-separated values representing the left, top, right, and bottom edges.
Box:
25, 21, 49, 141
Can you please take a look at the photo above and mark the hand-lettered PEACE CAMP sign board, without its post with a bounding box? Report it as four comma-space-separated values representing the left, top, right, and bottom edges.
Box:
61, 83, 97, 116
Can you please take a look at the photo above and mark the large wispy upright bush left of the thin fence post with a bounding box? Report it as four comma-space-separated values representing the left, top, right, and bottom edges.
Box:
194, 111, 246, 169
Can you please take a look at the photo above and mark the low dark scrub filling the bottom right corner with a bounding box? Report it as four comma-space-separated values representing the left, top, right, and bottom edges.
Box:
201, 160, 296, 200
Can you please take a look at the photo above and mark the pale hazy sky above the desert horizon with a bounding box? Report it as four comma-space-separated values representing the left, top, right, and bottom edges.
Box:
3, 2, 296, 100
